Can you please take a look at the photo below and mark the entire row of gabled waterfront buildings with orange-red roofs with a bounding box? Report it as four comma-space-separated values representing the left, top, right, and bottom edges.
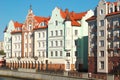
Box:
4, 0, 120, 73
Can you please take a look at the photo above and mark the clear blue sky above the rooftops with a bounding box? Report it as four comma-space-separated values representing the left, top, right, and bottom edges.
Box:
0, 0, 116, 41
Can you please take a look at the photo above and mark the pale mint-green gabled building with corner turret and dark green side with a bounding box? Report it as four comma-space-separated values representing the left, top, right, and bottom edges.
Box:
48, 7, 93, 71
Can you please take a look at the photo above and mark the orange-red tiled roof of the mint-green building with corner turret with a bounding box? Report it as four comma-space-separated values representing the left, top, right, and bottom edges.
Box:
60, 9, 87, 26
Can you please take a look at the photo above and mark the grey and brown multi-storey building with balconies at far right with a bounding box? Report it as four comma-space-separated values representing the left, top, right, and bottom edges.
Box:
87, 0, 120, 73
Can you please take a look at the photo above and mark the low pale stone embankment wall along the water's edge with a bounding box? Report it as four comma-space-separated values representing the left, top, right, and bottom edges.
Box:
0, 70, 87, 80
